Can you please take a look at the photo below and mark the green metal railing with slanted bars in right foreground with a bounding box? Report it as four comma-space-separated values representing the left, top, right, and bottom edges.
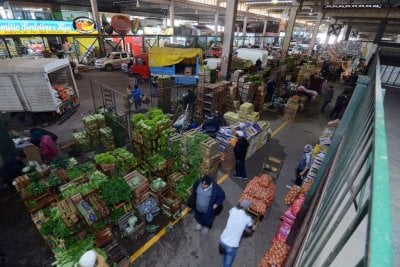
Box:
292, 56, 393, 267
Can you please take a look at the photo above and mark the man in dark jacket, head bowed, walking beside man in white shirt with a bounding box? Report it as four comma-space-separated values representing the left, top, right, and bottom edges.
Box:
188, 175, 225, 235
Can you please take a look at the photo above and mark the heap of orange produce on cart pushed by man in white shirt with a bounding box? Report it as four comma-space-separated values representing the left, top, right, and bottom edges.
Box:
239, 174, 276, 215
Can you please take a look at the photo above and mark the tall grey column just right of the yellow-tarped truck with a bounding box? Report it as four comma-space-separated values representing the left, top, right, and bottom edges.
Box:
221, 0, 238, 80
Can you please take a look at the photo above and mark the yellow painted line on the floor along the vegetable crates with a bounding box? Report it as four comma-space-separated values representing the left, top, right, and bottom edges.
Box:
130, 122, 288, 263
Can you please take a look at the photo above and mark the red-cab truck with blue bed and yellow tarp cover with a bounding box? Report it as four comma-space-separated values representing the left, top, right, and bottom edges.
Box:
122, 47, 203, 85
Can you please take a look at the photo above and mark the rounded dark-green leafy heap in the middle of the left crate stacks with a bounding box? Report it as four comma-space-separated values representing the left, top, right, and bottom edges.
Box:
99, 177, 132, 206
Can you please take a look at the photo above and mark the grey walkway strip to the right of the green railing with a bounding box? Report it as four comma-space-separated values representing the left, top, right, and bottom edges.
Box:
384, 87, 400, 266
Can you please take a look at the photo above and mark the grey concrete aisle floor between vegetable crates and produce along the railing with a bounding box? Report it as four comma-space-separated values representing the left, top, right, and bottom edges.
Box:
133, 96, 332, 267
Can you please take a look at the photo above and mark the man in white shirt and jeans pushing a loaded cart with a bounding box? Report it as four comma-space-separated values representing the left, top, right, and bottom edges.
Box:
219, 199, 254, 267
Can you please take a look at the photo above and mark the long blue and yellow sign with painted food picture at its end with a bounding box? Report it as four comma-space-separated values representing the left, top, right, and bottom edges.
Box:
0, 17, 98, 36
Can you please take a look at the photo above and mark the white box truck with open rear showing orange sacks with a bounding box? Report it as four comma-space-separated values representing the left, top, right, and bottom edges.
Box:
0, 58, 79, 126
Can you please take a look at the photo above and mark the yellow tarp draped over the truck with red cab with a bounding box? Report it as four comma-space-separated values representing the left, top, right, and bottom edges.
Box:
149, 47, 203, 67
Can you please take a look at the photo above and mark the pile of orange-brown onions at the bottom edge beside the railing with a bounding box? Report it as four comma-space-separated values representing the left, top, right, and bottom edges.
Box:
258, 241, 290, 267
